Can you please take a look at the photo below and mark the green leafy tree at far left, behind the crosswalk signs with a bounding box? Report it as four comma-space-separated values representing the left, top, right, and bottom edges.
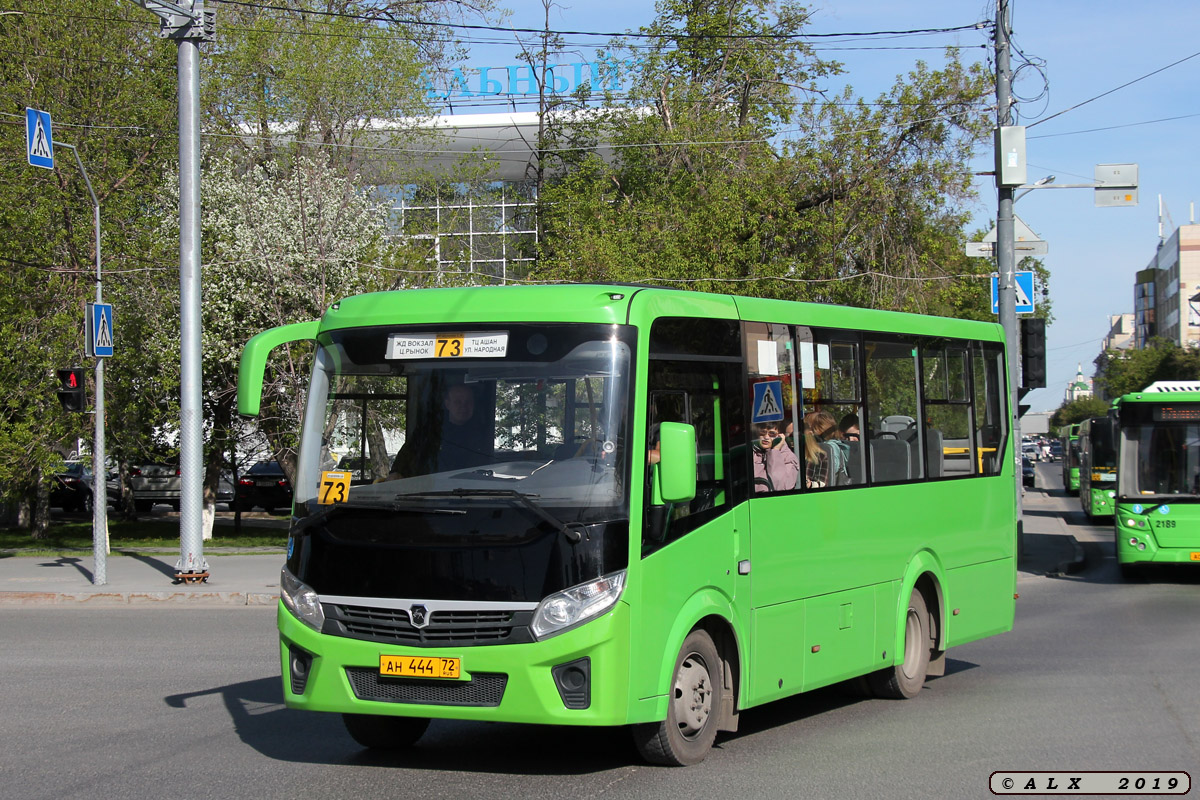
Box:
0, 0, 175, 536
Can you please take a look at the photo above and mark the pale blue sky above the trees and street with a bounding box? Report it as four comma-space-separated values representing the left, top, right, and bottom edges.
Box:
451, 0, 1200, 411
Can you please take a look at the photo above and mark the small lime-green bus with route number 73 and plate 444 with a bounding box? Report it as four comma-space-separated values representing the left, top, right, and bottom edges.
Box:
239, 285, 1016, 765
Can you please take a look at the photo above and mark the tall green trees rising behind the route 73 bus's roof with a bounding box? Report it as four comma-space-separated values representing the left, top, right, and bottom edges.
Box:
534, 0, 1012, 319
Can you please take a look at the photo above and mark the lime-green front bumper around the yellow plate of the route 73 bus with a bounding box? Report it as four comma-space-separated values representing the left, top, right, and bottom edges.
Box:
277, 602, 630, 726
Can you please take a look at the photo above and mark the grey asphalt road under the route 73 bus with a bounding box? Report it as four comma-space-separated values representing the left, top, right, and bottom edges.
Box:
0, 464, 1200, 800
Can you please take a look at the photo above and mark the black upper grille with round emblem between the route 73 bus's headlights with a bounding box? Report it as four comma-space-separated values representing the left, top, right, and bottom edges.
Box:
322, 603, 533, 648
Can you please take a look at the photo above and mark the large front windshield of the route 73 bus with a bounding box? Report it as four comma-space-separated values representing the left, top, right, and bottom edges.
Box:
295, 324, 632, 531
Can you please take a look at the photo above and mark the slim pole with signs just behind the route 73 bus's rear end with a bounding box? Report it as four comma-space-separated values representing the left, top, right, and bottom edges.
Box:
996, 0, 1024, 537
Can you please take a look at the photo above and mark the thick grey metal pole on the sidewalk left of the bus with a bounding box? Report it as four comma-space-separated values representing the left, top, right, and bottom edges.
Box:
126, 0, 216, 583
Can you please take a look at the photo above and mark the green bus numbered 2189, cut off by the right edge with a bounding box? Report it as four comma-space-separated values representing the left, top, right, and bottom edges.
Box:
1112, 380, 1200, 578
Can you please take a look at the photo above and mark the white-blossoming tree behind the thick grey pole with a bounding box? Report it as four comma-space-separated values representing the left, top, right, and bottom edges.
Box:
152, 152, 419, 537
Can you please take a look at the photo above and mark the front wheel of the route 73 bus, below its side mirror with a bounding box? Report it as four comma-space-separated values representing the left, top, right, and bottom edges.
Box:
634, 631, 724, 766
